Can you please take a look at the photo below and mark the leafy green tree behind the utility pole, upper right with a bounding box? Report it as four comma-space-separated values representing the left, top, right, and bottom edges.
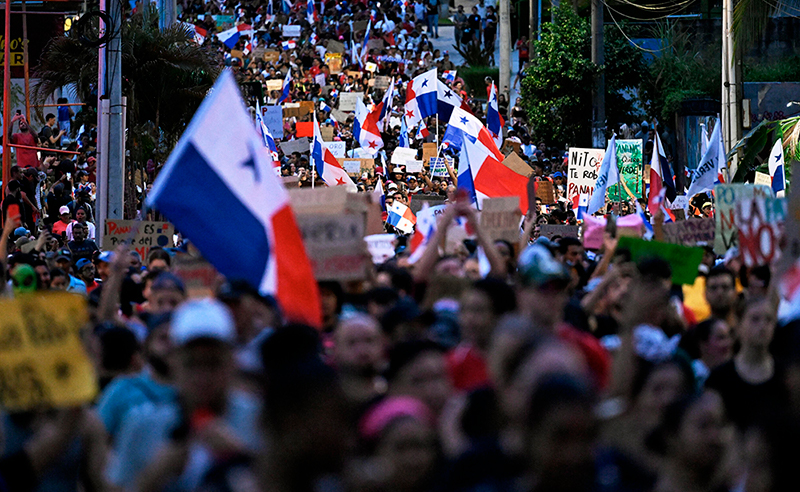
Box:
521, 3, 646, 146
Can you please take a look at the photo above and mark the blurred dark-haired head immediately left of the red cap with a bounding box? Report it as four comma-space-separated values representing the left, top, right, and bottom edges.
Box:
386, 340, 452, 415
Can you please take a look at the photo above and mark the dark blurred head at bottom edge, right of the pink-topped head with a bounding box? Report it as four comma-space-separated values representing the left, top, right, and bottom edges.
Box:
525, 374, 597, 491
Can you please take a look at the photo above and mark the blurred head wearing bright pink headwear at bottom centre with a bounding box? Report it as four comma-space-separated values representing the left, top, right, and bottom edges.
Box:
359, 396, 439, 491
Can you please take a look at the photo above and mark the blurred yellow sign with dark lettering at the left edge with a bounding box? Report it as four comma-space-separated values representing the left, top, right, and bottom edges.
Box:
0, 292, 97, 412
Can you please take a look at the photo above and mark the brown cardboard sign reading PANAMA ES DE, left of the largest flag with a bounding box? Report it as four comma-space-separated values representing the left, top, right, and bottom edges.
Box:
102, 219, 175, 262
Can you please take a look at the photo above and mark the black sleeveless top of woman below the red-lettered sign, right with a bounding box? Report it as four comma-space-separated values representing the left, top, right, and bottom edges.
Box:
706, 360, 786, 429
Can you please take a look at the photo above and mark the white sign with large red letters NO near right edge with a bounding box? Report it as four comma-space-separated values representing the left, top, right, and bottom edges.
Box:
736, 197, 786, 267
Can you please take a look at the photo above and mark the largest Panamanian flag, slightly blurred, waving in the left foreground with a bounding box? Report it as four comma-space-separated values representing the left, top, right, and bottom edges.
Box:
147, 71, 321, 326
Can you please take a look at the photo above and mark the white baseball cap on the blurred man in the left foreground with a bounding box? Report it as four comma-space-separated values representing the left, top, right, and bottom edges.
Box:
169, 299, 236, 346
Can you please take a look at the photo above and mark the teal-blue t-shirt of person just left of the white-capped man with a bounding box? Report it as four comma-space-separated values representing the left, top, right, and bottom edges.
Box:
97, 370, 176, 440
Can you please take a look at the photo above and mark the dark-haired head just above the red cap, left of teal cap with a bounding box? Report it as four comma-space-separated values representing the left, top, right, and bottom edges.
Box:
458, 278, 517, 350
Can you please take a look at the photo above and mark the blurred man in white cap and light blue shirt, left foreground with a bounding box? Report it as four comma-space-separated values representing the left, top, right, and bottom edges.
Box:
107, 299, 260, 491
